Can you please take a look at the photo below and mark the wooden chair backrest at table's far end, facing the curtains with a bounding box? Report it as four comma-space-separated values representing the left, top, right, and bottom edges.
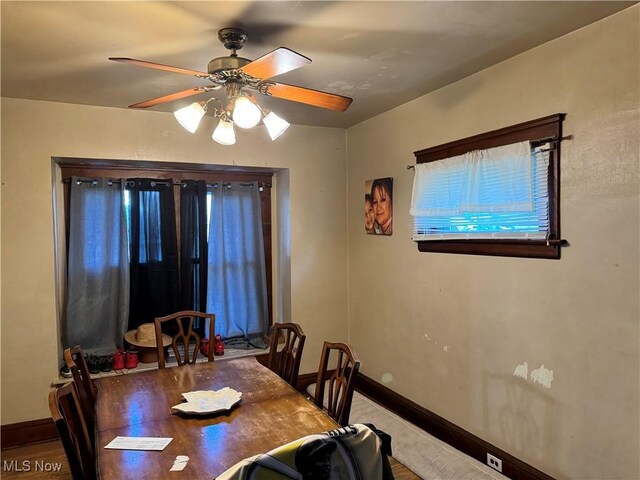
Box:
155, 310, 216, 368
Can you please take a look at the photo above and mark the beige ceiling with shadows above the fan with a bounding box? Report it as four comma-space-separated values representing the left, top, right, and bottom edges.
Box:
0, 1, 635, 127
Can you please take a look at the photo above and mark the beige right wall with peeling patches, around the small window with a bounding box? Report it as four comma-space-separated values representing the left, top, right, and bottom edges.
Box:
347, 7, 640, 479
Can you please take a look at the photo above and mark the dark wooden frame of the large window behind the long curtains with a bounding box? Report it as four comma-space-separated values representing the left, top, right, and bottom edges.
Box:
60, 158, 274, 325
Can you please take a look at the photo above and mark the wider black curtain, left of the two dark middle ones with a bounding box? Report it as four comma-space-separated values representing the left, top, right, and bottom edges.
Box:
127, 178, 180, 329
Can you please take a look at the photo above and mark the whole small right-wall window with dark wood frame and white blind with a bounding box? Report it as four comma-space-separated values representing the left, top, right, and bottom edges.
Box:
411, 114, 564, 259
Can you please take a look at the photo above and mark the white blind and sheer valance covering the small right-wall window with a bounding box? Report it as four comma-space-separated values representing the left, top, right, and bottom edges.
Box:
410, 142, 549, 241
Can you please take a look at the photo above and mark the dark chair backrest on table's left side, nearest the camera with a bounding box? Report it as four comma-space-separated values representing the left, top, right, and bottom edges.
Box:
49, 383, 96, 480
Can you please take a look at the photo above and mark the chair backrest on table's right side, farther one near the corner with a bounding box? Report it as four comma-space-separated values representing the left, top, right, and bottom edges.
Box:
269, 323, 307, 388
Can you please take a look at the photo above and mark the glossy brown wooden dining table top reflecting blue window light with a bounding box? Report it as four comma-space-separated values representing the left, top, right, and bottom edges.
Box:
96, 357, 339, 480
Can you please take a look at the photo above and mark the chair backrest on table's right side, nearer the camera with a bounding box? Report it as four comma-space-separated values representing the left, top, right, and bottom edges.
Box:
314, 342, 360, 427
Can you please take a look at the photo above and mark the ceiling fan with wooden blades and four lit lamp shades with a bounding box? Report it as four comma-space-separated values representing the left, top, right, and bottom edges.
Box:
109, 28, 352, 145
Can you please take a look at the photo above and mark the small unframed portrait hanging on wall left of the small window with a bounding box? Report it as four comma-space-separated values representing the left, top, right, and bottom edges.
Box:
364, 177, 393, 235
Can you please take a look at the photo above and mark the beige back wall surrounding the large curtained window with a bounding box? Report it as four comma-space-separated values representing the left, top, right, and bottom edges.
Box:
1, 98, 347, 425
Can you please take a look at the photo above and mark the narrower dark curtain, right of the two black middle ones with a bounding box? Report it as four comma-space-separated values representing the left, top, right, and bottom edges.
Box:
180, 180, 208, 334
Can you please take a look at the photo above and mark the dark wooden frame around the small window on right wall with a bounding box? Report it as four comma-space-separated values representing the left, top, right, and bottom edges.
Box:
413, 113, 565, 260
